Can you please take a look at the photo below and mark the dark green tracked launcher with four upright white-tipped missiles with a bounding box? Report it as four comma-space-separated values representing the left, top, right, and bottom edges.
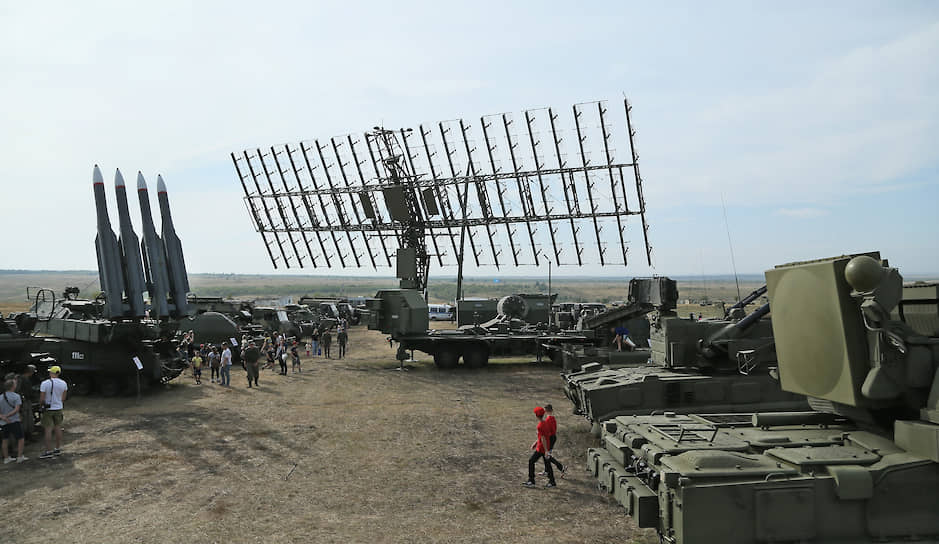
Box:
0, 166, 220, 395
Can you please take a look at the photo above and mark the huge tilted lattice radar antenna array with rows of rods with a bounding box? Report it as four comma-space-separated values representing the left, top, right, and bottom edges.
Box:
231, 99, 652, 290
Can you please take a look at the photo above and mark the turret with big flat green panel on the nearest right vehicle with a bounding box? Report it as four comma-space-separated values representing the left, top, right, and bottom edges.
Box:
766, 253, 939, 461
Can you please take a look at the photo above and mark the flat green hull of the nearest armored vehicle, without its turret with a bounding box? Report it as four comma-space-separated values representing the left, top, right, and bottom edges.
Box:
587, 412, 939, 544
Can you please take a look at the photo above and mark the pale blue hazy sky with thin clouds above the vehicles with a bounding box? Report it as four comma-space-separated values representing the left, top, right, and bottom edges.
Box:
0, 1, 939, 277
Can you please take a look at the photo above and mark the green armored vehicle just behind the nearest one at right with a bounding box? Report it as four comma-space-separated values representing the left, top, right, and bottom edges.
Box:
562, 278, 808, 434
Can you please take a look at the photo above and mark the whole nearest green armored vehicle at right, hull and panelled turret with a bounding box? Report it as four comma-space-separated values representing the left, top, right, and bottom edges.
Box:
587, 253, 939, 544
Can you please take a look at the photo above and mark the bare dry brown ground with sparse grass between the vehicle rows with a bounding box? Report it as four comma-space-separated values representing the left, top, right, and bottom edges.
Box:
0, 327, 658, 544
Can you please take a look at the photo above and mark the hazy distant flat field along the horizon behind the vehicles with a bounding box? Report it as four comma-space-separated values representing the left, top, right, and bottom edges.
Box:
0, 271, 762, 312
